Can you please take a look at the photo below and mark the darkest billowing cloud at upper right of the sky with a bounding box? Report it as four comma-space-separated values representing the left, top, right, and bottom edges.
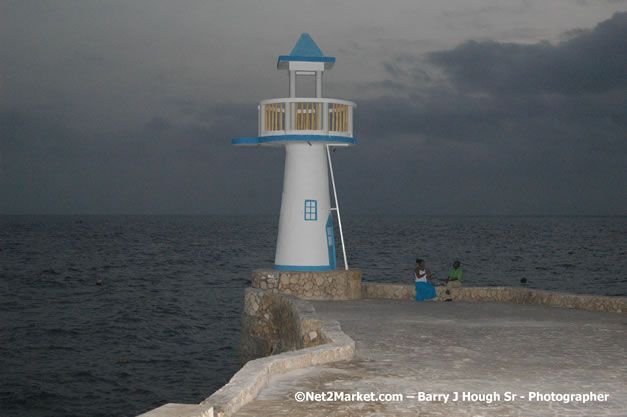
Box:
430, 13, 627, 94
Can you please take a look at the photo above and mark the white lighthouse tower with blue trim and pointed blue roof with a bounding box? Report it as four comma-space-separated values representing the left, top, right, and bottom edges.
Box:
233, 33, 356, 271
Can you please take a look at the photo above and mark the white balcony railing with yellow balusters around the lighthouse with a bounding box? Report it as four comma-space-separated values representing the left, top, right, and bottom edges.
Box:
258, 97, 356, 137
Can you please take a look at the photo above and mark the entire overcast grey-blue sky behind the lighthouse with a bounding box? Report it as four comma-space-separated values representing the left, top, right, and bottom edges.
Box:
0, 0, 627, 216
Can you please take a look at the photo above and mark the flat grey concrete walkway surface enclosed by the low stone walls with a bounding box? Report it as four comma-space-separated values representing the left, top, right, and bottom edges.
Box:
236, 300, 627, 417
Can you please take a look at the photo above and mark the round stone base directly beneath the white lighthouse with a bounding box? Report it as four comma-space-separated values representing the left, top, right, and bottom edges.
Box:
252, 269, 361, 300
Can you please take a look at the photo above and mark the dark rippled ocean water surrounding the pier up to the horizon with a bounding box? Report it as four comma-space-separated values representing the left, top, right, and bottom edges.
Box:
0, 215, 627, 417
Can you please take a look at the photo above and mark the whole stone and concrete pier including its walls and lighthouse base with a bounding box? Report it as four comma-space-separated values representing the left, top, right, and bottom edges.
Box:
141, 284, 627, 417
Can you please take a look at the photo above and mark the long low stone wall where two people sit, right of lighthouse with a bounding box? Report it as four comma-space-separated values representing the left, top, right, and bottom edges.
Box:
362, 283, 627, 313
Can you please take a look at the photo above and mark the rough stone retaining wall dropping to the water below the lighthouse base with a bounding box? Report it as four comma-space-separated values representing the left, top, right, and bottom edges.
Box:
240, 288, 327, 364
